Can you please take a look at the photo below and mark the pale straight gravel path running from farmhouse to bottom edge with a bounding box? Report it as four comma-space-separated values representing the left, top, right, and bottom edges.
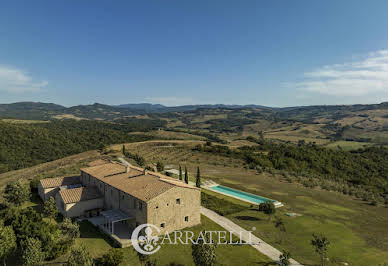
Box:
201, 206, 302, 265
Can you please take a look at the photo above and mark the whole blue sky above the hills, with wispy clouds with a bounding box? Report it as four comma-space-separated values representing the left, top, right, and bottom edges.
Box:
0, 0, 388, 106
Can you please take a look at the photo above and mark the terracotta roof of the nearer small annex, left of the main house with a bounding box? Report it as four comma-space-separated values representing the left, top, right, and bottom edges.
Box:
59, 186, 104, 204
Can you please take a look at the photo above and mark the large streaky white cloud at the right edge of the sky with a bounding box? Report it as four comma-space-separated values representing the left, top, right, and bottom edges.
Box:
288, 50, 388, 99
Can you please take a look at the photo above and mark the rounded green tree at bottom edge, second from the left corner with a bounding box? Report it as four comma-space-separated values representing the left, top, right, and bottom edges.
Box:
21, 238, 45, 266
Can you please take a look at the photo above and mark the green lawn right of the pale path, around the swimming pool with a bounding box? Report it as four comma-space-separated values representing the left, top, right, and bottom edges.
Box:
204, 190, 388, 265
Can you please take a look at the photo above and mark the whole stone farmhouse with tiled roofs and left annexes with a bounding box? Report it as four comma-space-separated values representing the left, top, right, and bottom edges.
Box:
38, 160, 201, 243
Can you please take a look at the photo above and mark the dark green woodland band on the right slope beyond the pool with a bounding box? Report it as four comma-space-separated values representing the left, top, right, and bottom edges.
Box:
193, 139, 388, 202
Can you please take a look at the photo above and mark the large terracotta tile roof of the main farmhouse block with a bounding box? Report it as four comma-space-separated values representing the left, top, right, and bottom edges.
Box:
81, 163, 198, 202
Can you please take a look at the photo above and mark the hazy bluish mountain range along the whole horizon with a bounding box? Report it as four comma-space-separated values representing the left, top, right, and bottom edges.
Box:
0, 102, 388, 120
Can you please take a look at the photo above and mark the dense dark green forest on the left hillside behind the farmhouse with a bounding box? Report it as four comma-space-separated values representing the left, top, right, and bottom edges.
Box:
0, 120, 156, 173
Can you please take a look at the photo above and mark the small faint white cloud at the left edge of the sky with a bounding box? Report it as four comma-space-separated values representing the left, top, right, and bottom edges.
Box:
0, 65, 48, 93
